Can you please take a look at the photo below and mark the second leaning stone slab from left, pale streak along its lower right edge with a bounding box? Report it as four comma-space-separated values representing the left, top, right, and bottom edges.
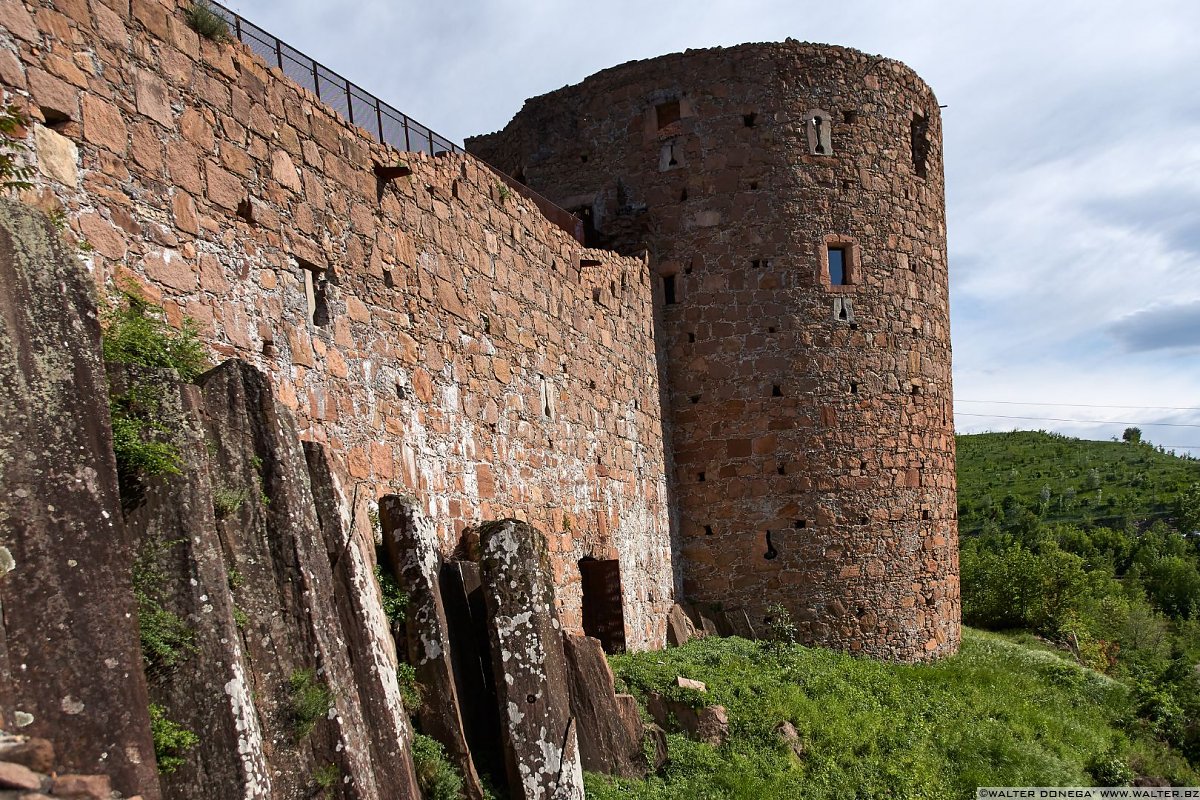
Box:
109, 374, 274, 800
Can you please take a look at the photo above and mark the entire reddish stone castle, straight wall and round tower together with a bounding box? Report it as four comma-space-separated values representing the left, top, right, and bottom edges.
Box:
0, 0, 959, 681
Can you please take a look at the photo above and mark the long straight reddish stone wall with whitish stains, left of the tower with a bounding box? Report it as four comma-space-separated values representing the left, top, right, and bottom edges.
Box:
0, 0, 673, 646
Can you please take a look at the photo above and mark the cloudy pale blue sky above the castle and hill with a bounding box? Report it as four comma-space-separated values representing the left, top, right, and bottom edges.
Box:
227, 0, 1200, 456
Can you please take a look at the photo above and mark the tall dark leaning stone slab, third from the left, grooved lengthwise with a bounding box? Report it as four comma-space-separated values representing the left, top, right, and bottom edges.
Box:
199, 361, 380, 799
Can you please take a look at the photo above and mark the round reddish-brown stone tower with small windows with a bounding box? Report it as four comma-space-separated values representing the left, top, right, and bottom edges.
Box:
468, 40, 960, 661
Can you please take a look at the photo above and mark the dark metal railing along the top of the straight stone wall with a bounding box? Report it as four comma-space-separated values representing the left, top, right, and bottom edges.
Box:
209, 2, 583, 243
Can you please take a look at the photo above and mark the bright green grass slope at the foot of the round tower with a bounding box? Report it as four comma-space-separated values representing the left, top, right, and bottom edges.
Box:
587, 630, 1196, 800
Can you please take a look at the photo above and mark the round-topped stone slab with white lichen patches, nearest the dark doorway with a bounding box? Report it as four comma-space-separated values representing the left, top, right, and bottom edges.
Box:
479, 519, 583, 800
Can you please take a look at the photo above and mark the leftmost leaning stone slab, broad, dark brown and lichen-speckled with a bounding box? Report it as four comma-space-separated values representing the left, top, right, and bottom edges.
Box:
0, 200, 158, 799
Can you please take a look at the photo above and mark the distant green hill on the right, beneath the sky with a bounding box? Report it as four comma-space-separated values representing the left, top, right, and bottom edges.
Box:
958, 431, 1200, 534
